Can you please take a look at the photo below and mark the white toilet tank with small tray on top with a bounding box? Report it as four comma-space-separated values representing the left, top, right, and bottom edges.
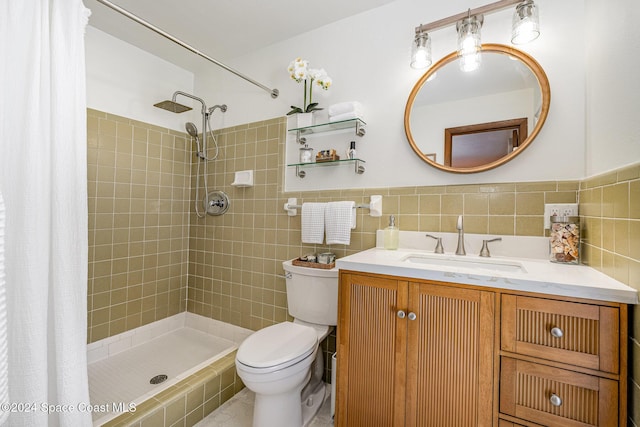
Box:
282, 261, 338, 326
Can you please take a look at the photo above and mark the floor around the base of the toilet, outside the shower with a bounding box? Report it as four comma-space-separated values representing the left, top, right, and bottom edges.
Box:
195, 388, 333, 427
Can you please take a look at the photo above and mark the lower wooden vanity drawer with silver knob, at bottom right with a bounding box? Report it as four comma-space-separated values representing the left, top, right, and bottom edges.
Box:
500, 357, 618, 427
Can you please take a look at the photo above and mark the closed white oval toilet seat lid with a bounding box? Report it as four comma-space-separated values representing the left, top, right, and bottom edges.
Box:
236, 322, 318, 368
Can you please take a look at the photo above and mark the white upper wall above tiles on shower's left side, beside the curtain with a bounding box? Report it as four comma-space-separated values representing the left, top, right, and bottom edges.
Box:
85, 26, 196, 132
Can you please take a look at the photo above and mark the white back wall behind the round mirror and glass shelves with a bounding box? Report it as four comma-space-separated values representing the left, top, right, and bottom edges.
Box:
195, 0, 592, 190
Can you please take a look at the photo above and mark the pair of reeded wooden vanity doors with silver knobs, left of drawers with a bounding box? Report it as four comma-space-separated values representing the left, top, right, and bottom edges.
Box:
335, 272, 495, 427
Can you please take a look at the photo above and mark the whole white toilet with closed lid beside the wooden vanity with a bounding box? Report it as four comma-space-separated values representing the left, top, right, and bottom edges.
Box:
236, 261, 338, 427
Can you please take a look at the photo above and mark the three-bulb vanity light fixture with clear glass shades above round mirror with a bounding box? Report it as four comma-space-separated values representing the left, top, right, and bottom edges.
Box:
411, 0, 540, 71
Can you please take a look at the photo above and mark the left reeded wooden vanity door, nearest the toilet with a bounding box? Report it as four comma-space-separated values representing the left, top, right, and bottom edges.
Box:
336, 274, 407, 427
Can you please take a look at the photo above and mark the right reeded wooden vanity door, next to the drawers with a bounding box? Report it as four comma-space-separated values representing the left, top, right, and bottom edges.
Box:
407, 283, 495, 427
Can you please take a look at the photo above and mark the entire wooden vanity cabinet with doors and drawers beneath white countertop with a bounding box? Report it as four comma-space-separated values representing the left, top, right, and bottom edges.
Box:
335, 270, 628, 427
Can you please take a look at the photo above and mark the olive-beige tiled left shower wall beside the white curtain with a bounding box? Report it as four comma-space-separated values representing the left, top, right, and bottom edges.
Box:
87, 109, 191, 342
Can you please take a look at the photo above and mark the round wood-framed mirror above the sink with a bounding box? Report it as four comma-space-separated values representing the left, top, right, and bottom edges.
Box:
404, 44, 551, 173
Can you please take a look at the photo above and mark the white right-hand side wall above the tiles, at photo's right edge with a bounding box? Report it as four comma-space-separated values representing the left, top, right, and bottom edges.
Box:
585, 0, 640, 176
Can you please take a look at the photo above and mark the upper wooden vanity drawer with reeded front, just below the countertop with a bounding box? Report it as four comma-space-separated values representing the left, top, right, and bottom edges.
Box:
500, 295, 620, 374
